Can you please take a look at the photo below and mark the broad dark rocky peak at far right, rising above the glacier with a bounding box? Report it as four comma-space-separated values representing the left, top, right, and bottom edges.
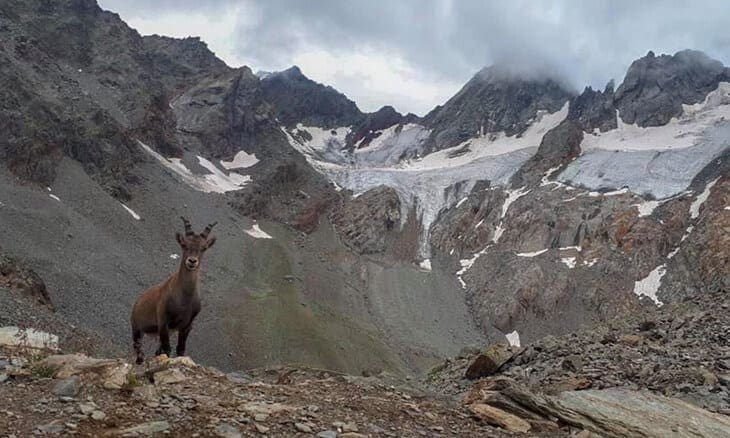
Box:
615, 50, 730, 127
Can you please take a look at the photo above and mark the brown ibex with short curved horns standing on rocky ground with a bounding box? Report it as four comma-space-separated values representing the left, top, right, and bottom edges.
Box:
132, 217, 217, 364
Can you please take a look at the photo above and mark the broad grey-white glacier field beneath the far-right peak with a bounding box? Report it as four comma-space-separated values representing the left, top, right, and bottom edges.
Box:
558, 82, 730, 198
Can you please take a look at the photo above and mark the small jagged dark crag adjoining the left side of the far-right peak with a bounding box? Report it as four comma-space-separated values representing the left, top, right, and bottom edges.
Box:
568, 81, 617, 133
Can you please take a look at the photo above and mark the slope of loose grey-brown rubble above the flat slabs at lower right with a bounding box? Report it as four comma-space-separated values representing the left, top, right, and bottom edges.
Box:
428, 292, 730, 418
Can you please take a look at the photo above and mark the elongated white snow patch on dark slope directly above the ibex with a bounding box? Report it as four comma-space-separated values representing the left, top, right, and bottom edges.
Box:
137, 140, 251, 193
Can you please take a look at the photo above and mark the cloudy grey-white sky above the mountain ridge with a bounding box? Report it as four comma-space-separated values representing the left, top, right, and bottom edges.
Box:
99, 0, 730, 115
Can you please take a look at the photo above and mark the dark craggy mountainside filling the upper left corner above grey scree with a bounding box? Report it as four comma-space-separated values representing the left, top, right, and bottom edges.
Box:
0, 1, 229, 196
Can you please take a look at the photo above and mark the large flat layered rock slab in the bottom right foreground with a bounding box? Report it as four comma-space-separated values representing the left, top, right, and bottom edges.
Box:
460, 379, 730, 438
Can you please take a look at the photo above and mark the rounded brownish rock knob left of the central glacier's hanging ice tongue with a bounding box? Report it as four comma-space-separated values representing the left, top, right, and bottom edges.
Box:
331, 186, 401, 254
